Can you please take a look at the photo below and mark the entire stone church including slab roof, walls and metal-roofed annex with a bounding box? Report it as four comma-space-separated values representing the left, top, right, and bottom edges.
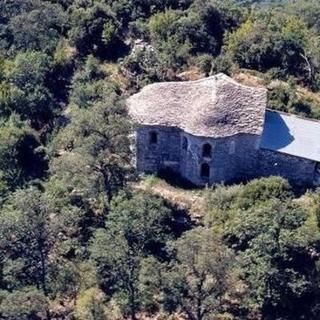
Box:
127, 74, 320, 186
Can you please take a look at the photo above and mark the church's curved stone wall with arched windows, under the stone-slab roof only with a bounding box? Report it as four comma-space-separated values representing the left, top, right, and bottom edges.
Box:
136, 126, 259, 185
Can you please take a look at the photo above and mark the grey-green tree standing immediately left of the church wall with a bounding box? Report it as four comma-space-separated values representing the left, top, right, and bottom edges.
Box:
51, 87, 131, 205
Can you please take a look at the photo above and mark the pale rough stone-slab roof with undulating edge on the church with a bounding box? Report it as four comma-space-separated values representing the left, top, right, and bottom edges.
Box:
127, 74, 267, 138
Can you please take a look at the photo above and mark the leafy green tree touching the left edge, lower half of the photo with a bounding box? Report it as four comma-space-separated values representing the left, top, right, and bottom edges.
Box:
0, 188, 56, 294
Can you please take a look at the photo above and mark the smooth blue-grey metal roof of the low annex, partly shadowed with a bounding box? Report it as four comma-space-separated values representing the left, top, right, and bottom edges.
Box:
260, 110, 320, 162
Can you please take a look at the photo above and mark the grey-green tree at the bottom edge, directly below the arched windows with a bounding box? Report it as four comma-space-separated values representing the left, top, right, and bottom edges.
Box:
165, 227, 236, 320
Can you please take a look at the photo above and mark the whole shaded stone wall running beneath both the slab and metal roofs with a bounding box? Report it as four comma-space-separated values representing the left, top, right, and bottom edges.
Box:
135, 126, 316, 186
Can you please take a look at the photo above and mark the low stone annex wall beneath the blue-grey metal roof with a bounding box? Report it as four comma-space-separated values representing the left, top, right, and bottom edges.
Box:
256, 149, 316, 186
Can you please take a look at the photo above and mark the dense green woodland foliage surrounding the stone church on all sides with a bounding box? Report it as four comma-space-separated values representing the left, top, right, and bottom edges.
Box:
0, 0, 320, 320
